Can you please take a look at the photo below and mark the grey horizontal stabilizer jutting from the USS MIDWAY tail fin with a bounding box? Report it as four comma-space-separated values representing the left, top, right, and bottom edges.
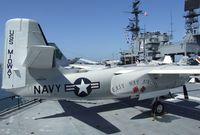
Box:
24, 45, 55, 69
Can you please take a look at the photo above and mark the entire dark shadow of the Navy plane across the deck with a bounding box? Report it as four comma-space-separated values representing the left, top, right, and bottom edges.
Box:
36, 98, 200, 134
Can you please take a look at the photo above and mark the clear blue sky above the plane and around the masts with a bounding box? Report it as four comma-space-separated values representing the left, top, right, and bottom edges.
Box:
0, 0, 185, 61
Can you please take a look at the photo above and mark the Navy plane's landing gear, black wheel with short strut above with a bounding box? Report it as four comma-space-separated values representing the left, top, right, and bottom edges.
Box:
152, 98, 165, 116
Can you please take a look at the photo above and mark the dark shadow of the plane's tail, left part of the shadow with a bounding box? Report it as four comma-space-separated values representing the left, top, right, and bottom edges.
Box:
36, 100, 120, 134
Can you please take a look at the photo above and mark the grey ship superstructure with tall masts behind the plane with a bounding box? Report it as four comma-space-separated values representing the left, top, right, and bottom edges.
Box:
121, 0, 200, 64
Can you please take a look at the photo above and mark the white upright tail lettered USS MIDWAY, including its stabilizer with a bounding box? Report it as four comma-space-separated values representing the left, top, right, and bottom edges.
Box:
2, 18, 54, 89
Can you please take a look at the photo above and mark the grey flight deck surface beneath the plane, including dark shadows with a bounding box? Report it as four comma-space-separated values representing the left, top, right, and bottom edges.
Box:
0, 85, 200, 135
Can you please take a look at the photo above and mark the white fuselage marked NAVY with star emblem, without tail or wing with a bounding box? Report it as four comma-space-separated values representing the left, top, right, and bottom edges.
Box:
12, 66, 188, 100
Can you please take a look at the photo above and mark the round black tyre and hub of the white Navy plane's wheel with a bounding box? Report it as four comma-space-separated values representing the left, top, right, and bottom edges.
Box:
152, 101, 165, 116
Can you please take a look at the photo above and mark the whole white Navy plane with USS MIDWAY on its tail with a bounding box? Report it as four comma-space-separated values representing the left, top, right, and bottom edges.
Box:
2, 18, 200, 114
